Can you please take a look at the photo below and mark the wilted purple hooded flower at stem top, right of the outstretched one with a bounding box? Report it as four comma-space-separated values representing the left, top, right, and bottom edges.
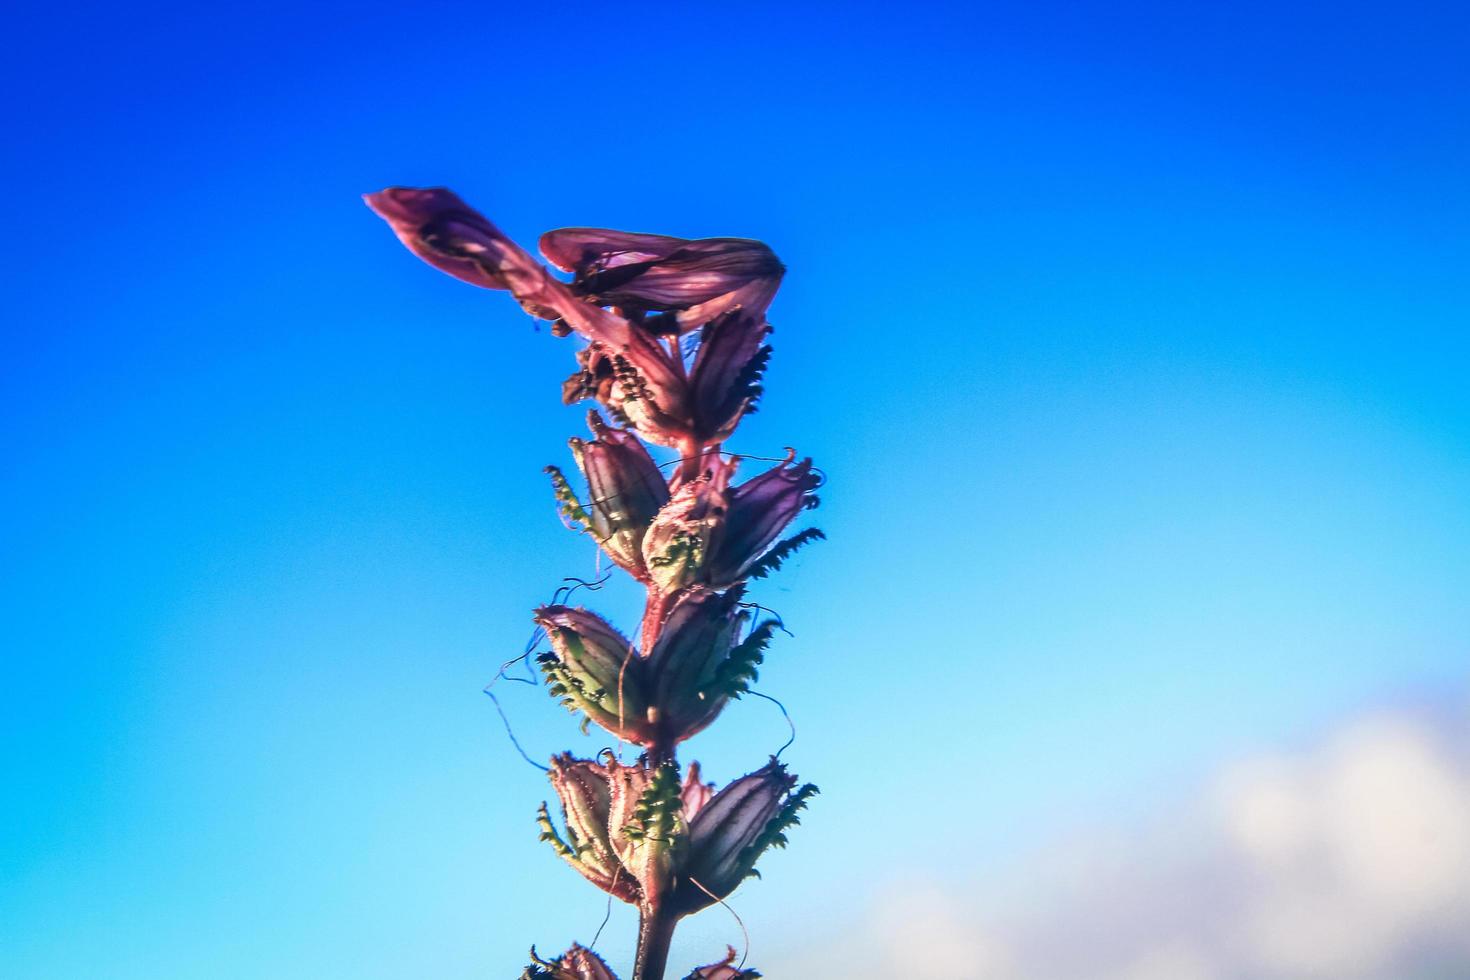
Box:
541, 228, 785, 334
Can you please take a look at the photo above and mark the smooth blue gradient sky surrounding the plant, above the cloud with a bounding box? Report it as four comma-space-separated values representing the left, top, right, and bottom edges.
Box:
0, 3, 1470, 980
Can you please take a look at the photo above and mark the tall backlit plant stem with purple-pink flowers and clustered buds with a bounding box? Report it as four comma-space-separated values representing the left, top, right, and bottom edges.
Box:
366, 188, 822, 980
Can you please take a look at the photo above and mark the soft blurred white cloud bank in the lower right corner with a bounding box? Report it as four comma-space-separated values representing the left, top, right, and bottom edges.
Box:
764, 714, 1470, 980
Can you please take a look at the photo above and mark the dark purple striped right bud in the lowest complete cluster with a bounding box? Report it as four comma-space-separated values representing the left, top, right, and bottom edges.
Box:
673, 760, 817, 914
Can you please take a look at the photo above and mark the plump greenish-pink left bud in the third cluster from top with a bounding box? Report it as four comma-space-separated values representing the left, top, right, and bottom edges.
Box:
535, 605, 654, 743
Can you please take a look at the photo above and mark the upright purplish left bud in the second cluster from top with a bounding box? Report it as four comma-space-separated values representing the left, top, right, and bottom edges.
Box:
547, 411, 669, 582
